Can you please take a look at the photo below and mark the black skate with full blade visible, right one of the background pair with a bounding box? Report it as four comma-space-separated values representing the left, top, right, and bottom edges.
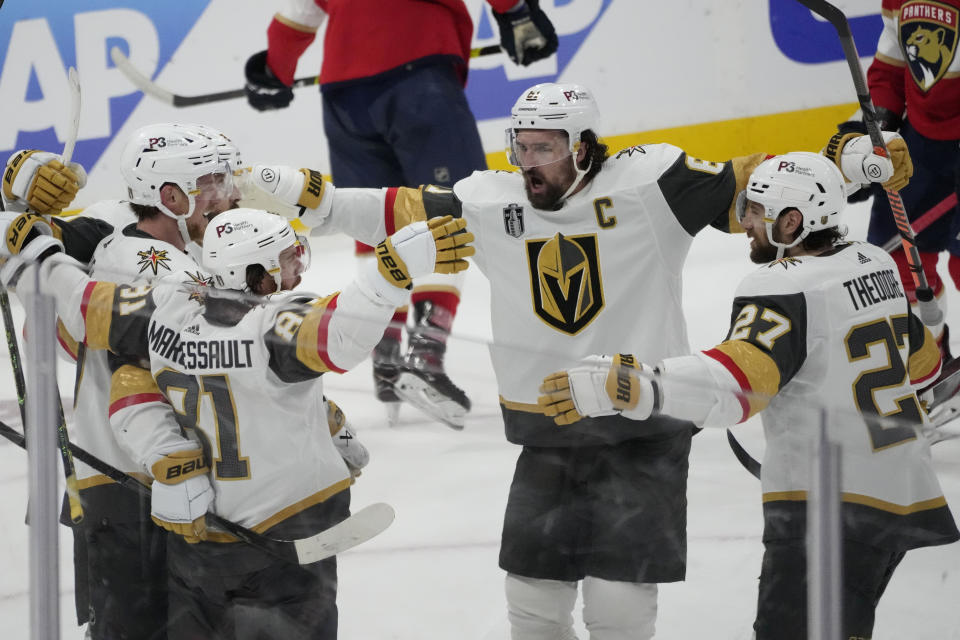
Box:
393, 301, 470, 431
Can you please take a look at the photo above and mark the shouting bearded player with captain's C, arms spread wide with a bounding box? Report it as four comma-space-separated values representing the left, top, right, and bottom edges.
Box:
240, 84, 909, 640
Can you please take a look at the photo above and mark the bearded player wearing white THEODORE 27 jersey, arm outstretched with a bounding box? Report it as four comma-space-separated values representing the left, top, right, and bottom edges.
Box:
539, 152, 960, 640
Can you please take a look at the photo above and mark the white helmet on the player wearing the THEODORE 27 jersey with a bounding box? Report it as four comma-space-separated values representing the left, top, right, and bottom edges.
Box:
737, 151, 847, 257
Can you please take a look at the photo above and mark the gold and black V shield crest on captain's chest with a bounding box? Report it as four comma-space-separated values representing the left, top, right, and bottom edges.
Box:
527, 233, 603, 335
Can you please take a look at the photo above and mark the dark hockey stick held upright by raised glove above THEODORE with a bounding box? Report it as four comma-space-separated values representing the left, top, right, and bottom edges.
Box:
797, 0, 943, 327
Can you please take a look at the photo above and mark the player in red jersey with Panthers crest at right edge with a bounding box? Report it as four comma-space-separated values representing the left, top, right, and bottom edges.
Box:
840, 0, 960, 355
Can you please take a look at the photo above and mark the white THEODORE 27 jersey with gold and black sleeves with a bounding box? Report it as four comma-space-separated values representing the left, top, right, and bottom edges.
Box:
659, 243, 957, 549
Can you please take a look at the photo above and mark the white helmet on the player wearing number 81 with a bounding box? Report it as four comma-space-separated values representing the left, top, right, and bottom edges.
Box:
202, 209, 310, 291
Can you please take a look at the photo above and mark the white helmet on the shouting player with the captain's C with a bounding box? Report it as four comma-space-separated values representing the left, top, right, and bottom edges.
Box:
507, 82, 600, 167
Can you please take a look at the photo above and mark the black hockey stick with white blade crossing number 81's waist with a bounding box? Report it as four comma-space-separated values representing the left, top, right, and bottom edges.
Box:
0, 422, 395, 565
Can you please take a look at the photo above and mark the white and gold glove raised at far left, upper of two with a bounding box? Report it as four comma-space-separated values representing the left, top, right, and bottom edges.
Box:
3, 149, 87, 215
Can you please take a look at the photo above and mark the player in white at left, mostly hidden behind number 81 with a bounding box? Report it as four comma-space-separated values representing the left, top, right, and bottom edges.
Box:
0, 123, 241, 640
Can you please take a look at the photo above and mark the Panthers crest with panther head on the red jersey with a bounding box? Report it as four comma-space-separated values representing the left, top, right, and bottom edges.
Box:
900, 0, 960, 91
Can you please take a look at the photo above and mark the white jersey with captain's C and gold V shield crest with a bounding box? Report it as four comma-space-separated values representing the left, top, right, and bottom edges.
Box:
454, 144, 764, 446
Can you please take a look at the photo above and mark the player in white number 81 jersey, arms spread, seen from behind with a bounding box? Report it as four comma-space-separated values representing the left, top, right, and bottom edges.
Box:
3, 209, 472, 638
